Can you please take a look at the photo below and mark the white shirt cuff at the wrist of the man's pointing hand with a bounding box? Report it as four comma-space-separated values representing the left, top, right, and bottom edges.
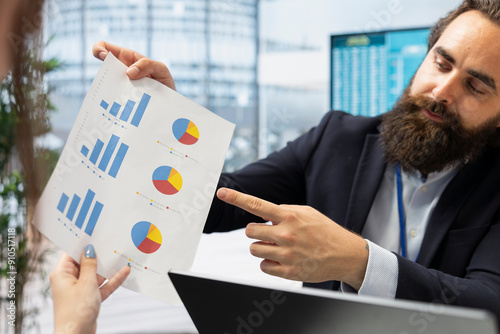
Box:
341, 240, 399, 299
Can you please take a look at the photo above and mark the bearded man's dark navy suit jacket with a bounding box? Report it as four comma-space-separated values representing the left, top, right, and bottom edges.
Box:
205, 112, 500, 319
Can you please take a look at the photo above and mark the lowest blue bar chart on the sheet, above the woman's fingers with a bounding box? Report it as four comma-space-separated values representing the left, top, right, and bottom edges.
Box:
57, 189, 104, 236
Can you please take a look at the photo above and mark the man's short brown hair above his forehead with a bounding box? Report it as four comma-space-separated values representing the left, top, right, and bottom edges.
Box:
428, 0, 500, 50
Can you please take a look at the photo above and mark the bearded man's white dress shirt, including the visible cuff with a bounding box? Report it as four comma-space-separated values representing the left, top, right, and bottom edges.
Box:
342, 165, 457, 298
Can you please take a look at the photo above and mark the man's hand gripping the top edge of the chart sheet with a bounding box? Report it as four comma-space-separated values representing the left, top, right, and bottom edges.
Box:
92, 41, 175, 90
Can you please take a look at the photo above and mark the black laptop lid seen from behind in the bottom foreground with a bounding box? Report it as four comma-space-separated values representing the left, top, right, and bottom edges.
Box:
169, 270, 498, 334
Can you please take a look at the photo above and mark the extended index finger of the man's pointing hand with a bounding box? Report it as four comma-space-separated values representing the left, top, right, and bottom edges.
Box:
217, 188, 282, 223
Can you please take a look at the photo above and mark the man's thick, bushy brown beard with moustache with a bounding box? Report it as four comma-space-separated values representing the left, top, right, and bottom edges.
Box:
382, 89, 500, 176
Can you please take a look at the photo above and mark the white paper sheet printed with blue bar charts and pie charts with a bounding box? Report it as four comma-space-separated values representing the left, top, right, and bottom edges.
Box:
34, 53, 234, 304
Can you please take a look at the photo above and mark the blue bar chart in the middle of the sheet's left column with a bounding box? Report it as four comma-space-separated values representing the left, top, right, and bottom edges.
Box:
80, 135, 129, 178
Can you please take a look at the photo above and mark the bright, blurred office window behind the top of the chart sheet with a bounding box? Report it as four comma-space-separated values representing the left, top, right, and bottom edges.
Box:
45, 0, 258, 170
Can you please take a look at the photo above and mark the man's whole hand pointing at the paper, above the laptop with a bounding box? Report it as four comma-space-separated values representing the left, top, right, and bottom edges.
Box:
217, 188, 368, 290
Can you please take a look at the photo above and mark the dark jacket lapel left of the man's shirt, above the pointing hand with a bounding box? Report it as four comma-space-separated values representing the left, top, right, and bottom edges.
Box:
345, 134, 385, 233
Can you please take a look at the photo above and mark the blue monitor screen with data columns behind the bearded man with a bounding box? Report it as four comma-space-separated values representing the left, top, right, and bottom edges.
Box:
330, 28, 430, 116
